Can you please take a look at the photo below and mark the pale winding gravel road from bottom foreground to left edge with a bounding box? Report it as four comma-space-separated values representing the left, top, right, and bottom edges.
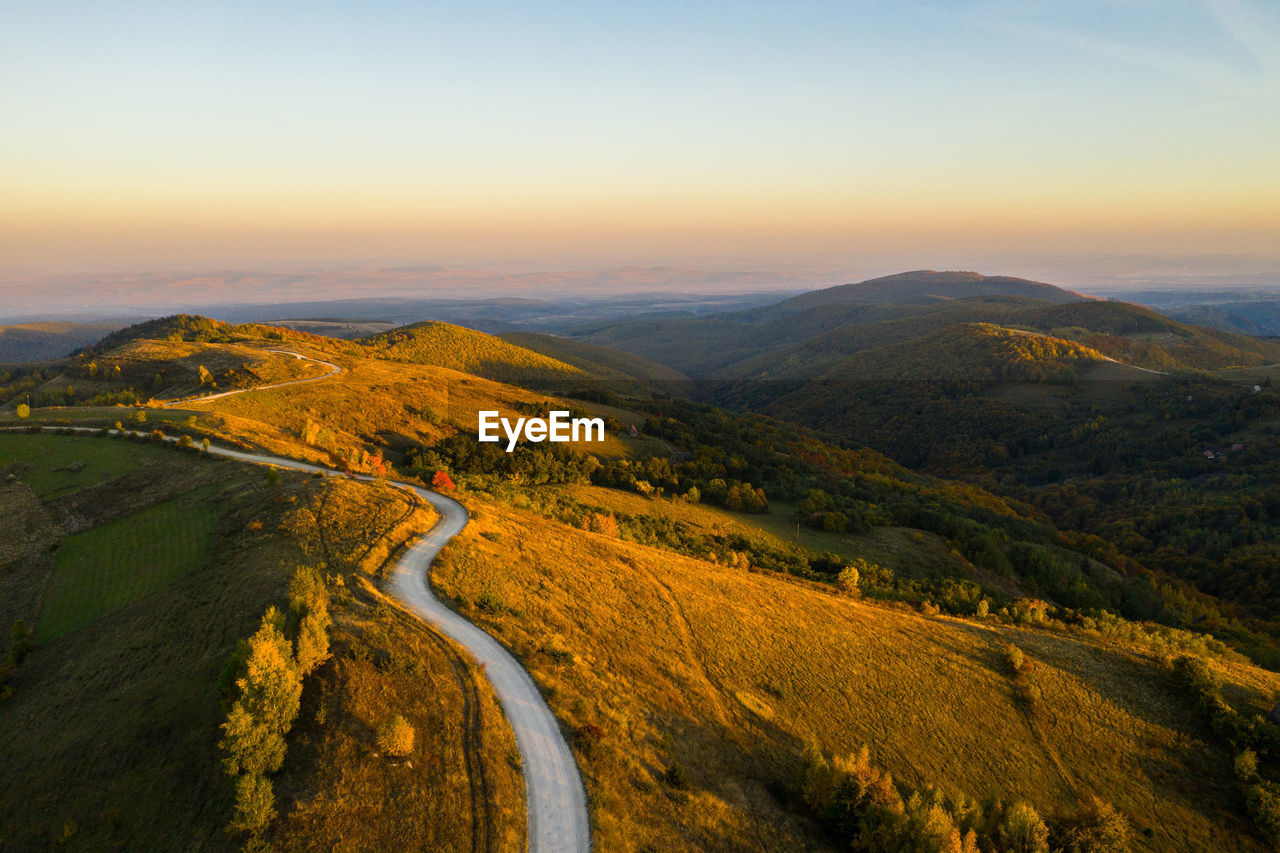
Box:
5, 427, 591, 853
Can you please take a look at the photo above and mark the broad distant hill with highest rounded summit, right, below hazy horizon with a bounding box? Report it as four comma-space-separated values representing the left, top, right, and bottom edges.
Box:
576, 272, 1280, 380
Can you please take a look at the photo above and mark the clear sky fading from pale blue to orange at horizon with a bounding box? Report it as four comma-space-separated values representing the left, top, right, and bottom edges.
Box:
0, 0, 1280, 272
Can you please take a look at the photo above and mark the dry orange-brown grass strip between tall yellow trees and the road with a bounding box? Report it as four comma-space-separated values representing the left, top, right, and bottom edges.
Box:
269, 480, 525, 850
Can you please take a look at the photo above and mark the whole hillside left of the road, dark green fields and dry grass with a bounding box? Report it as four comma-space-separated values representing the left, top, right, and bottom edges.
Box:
0, 434, 524, 850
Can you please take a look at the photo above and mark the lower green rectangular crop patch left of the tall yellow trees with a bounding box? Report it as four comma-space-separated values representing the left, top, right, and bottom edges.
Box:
37, 484, 220, 642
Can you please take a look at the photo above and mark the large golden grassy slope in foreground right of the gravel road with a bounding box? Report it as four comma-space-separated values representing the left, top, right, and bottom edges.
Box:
434, 491, 1280, 850
